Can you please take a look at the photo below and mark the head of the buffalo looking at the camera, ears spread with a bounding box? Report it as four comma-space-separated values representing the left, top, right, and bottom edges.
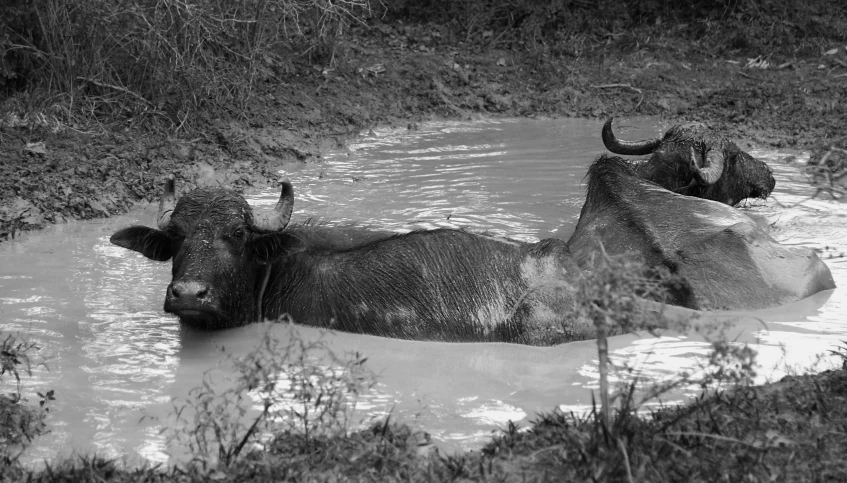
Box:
110, 177, 300, 328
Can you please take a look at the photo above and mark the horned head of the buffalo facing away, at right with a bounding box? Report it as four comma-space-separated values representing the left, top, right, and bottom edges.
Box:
602, 119, 776, 206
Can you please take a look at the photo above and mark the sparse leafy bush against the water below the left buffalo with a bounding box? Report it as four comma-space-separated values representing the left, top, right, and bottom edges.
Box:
167, 325, 375, 466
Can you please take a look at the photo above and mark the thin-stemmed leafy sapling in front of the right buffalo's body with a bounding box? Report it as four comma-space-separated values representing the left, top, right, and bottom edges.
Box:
576, 246, 756, 433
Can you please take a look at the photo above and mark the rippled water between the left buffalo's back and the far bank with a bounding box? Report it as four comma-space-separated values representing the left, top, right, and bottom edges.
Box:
245, 120, 628, 240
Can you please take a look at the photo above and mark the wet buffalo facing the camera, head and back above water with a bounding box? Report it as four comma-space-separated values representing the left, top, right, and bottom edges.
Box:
111, 180, 594, 344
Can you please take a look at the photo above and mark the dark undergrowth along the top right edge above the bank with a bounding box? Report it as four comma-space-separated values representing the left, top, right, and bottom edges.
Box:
387, 0, 847, 57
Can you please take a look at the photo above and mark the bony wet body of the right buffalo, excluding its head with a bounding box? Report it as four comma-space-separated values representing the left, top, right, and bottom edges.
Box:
568, 155, 835, 310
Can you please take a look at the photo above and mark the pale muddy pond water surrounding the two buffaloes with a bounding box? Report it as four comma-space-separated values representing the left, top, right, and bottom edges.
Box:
0, 120, 847, 464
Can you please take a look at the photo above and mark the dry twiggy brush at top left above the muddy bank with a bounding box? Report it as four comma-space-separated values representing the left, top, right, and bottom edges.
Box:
0, 0, 378, 128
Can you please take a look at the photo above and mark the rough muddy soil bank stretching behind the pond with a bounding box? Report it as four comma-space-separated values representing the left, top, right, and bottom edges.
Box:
0, 20, 847, 241
